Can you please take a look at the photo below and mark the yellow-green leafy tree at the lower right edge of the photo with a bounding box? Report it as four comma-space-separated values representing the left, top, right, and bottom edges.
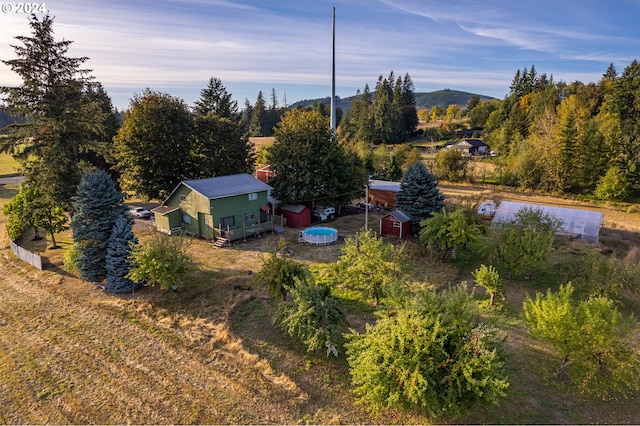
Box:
523, 283, 640, 399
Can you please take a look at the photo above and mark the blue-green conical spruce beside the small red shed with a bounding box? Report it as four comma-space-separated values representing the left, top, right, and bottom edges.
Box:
396, 162, 444, 232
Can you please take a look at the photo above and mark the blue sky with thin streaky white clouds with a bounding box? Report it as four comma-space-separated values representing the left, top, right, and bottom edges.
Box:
0, 0, 640, 109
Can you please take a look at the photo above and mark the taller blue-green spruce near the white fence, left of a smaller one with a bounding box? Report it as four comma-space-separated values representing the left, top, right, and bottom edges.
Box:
71, 170, 126, 282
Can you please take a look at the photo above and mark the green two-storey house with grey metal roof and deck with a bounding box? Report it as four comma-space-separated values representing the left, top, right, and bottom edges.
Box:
152, 173, 274, 242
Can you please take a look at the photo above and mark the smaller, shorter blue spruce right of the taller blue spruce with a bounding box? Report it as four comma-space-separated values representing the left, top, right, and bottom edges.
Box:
105, 216, 138, 293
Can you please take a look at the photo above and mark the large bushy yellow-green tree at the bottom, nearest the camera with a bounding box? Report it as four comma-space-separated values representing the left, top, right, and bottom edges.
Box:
345, 286, 509, 416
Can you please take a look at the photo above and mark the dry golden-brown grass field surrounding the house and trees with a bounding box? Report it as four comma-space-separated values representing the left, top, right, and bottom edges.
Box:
0, 181, 640, 424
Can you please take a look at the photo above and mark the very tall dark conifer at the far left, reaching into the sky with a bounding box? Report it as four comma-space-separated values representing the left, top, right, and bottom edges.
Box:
0, 15, 111, 210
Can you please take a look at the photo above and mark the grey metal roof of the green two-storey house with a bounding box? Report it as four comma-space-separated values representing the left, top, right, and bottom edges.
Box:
182, 173, 273, 200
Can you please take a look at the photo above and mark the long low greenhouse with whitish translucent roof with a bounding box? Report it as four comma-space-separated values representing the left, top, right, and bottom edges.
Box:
493, 201, 604, 243
